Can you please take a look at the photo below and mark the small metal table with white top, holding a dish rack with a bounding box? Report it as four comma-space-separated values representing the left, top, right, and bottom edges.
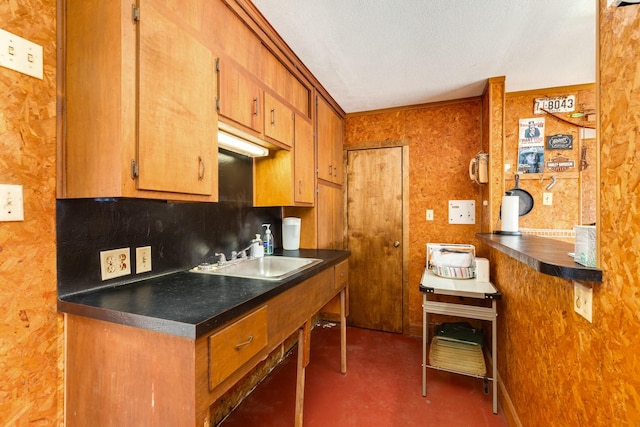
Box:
420, 267, 502, 414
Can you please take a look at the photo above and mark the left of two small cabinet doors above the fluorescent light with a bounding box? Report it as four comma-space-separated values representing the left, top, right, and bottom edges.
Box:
218, 61, 264, 133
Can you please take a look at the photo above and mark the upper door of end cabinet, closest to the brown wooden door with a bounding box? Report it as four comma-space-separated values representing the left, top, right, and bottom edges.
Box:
316, 96, 343, 184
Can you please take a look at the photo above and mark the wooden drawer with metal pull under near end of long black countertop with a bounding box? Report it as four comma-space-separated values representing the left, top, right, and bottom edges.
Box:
209, 306, 267, 390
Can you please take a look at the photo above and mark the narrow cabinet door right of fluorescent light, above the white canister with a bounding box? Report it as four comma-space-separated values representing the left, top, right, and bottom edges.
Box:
294, 117, 315, 204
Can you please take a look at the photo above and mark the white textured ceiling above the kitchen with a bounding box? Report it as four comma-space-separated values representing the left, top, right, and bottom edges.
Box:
253, 0, 596, 113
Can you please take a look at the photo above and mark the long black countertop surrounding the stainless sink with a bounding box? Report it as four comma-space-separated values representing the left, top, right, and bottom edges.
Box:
58, 249, 351, 339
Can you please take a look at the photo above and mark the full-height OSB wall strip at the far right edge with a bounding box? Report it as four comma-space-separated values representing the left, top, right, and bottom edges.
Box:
593, 0, 640, 425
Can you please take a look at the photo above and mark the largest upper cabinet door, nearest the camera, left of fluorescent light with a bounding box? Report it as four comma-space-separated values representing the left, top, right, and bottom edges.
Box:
136, 0, 218, 195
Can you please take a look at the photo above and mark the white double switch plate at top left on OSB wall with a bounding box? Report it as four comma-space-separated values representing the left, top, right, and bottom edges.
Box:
0, 29, 43, 79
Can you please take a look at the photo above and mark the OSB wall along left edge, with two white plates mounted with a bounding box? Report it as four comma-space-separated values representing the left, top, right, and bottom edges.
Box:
0, 0, 63, 426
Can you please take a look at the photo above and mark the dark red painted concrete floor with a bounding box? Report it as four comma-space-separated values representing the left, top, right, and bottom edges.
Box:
219, 324, 507, 427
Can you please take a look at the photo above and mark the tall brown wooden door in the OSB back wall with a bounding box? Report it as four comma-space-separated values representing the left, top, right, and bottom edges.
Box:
347, 147, 403, 333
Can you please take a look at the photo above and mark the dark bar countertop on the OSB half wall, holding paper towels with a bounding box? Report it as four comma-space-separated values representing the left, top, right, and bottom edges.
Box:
476, 233, 602, 283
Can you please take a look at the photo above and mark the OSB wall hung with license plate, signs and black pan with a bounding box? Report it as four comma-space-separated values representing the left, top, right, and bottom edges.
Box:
498, 84, 595, 230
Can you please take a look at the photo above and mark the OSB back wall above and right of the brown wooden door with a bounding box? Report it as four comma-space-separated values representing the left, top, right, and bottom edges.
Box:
344, 98, 482, 331
